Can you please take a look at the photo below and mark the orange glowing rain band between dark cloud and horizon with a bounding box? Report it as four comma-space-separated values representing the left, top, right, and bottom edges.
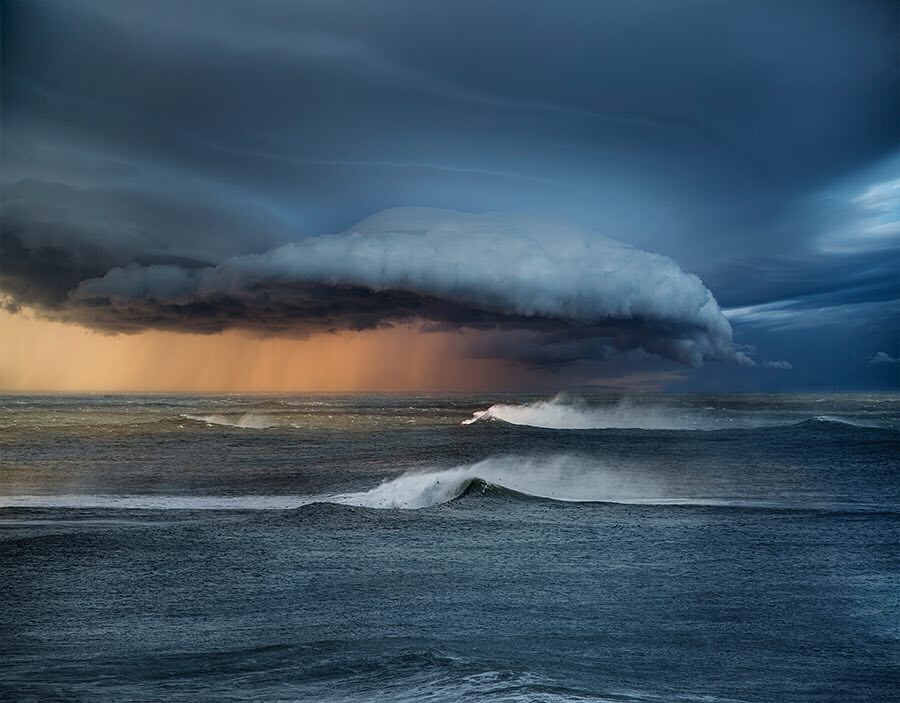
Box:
0, 312, 521, 392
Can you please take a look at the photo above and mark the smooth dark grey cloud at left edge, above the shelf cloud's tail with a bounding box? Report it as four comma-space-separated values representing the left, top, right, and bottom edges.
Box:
0, 179, 296, 307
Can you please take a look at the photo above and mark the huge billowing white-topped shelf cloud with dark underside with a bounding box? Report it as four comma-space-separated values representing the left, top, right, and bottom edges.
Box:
2, 208, 747, 366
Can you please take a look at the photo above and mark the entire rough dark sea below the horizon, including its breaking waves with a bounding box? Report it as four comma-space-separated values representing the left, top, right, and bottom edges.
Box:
0, 396, 900, 702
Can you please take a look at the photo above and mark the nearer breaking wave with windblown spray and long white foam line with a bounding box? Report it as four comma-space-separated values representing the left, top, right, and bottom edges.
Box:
0, 455, 897, 512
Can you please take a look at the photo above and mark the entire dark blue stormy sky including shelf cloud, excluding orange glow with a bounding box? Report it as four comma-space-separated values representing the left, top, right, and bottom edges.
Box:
0, 0, 900, 390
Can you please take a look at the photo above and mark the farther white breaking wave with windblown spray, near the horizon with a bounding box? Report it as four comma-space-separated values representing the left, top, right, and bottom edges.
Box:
462, 394, 734, 430
